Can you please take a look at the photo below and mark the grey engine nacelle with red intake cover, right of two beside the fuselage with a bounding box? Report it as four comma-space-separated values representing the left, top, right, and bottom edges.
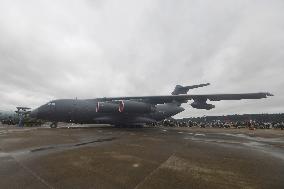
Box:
118, 100, 155, 113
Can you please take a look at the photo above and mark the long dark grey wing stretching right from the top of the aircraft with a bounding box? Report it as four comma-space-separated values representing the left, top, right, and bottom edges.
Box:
98, 92, 273, 104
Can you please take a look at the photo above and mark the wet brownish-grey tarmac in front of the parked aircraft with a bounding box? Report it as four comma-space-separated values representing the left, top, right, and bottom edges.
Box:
0, 124, 284, 189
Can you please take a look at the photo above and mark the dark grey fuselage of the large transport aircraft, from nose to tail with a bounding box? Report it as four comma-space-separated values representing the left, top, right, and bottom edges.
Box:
31, 99, 184, 124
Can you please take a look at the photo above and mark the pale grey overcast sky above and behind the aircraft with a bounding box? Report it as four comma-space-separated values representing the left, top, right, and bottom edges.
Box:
0, 0, 284, 117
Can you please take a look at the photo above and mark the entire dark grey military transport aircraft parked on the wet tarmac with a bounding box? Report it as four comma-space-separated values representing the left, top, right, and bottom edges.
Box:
30, 83, 273, 128
